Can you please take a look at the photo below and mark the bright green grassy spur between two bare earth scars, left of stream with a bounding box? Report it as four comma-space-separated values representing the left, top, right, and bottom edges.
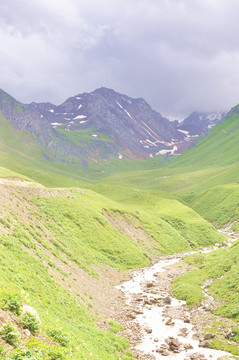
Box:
34, 191, 149, 271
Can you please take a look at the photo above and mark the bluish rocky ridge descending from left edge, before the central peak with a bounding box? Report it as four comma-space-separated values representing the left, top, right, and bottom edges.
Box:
0, 90, 88, 167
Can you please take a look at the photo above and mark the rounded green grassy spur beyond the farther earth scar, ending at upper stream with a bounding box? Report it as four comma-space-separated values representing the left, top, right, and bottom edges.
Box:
87, 185, 223, 252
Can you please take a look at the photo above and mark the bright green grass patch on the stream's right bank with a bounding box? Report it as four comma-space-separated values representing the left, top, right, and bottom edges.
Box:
172, 241, 239, 320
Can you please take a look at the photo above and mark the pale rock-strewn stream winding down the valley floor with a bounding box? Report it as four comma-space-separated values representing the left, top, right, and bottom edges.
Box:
117, 239, 235, 360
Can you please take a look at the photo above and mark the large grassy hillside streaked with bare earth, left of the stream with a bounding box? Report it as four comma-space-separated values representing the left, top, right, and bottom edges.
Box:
0, 183, 136, 360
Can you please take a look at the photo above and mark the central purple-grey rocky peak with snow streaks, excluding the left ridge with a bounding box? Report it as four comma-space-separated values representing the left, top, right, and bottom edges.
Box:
30, 88, 187, 158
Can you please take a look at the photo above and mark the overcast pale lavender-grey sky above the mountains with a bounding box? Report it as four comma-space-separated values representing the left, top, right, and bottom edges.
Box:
0, 0, 239, 117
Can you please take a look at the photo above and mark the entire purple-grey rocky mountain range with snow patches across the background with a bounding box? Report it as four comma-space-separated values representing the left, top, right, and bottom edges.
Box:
0, 87, 227, 167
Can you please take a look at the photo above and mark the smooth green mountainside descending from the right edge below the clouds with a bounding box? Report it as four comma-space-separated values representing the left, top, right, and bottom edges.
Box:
100, 106, 239, 197
